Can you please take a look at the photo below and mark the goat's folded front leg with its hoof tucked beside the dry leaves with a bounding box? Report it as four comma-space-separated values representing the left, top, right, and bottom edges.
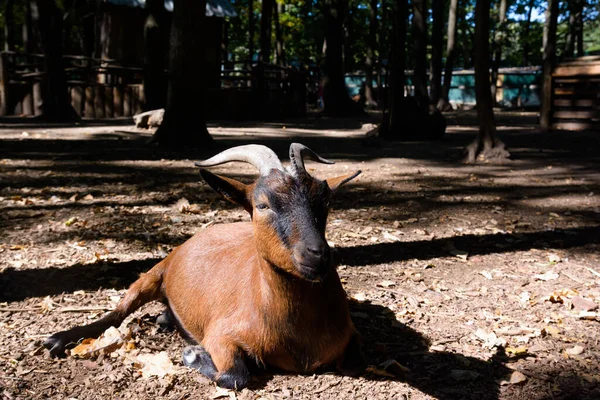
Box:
183, 340, 250, 390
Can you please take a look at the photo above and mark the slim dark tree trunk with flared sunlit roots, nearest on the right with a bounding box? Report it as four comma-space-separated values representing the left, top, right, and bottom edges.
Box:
465, 0, 510, 163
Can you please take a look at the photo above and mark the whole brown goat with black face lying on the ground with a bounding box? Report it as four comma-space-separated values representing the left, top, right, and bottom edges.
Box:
44, 143, 365, 389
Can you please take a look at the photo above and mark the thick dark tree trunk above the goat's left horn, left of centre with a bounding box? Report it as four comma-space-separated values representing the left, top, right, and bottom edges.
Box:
154, 0, 212, 149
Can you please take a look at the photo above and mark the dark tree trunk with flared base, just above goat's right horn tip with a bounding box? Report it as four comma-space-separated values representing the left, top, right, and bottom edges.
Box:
323, 0, 362, 117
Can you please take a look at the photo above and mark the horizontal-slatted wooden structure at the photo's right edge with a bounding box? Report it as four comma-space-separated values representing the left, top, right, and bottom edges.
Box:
551, 56, 600, 130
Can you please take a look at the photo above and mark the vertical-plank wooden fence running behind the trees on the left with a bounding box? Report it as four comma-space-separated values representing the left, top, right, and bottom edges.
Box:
0, 52, 306, 119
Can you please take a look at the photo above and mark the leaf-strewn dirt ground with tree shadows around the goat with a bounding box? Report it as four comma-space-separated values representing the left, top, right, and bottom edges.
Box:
0, 115, 600, 400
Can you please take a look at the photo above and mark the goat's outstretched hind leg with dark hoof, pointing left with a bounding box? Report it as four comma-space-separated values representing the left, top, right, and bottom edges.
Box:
44, 263, 163, 356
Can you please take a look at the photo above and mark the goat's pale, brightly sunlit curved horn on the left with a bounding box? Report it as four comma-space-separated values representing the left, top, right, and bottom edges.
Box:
194, 144, 285, 175
